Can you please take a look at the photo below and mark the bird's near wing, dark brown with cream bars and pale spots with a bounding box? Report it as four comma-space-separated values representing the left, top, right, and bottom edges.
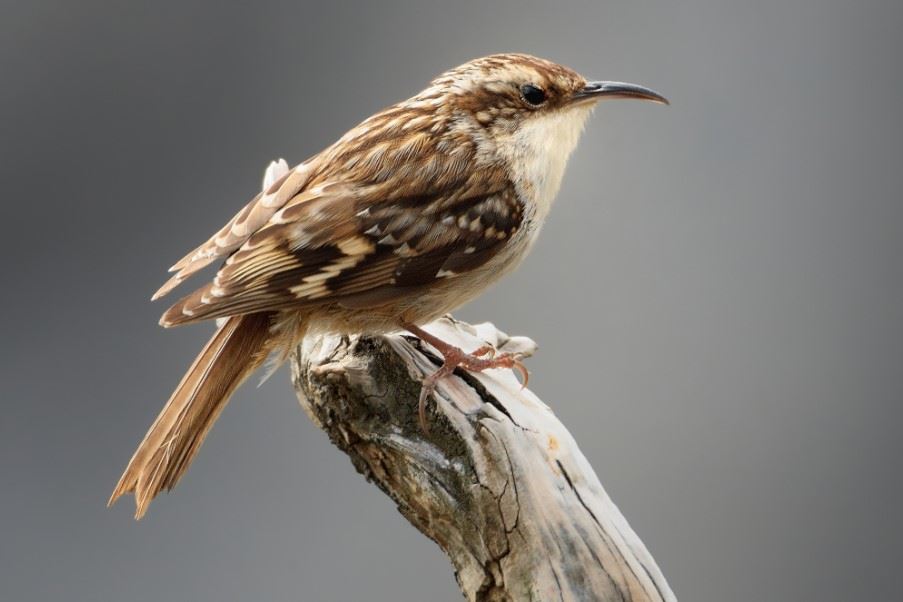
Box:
161, 174, 523, 326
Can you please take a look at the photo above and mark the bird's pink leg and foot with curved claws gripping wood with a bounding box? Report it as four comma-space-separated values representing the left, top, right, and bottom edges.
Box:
400, 322, 530, 433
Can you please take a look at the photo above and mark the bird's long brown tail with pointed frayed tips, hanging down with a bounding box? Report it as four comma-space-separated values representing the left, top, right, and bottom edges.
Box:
109, 312, 273, 518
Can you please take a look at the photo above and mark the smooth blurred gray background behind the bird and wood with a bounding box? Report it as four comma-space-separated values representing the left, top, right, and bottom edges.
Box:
0, 0, 903, 602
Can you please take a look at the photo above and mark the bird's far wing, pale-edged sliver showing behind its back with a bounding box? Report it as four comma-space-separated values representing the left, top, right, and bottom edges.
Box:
153, 159, 310, 299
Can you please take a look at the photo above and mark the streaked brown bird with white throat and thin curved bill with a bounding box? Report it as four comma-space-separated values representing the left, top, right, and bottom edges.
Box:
109, 53, 668, 519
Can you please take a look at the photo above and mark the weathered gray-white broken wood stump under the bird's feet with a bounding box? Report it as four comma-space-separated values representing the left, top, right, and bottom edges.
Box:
292, 318, 675, 601
